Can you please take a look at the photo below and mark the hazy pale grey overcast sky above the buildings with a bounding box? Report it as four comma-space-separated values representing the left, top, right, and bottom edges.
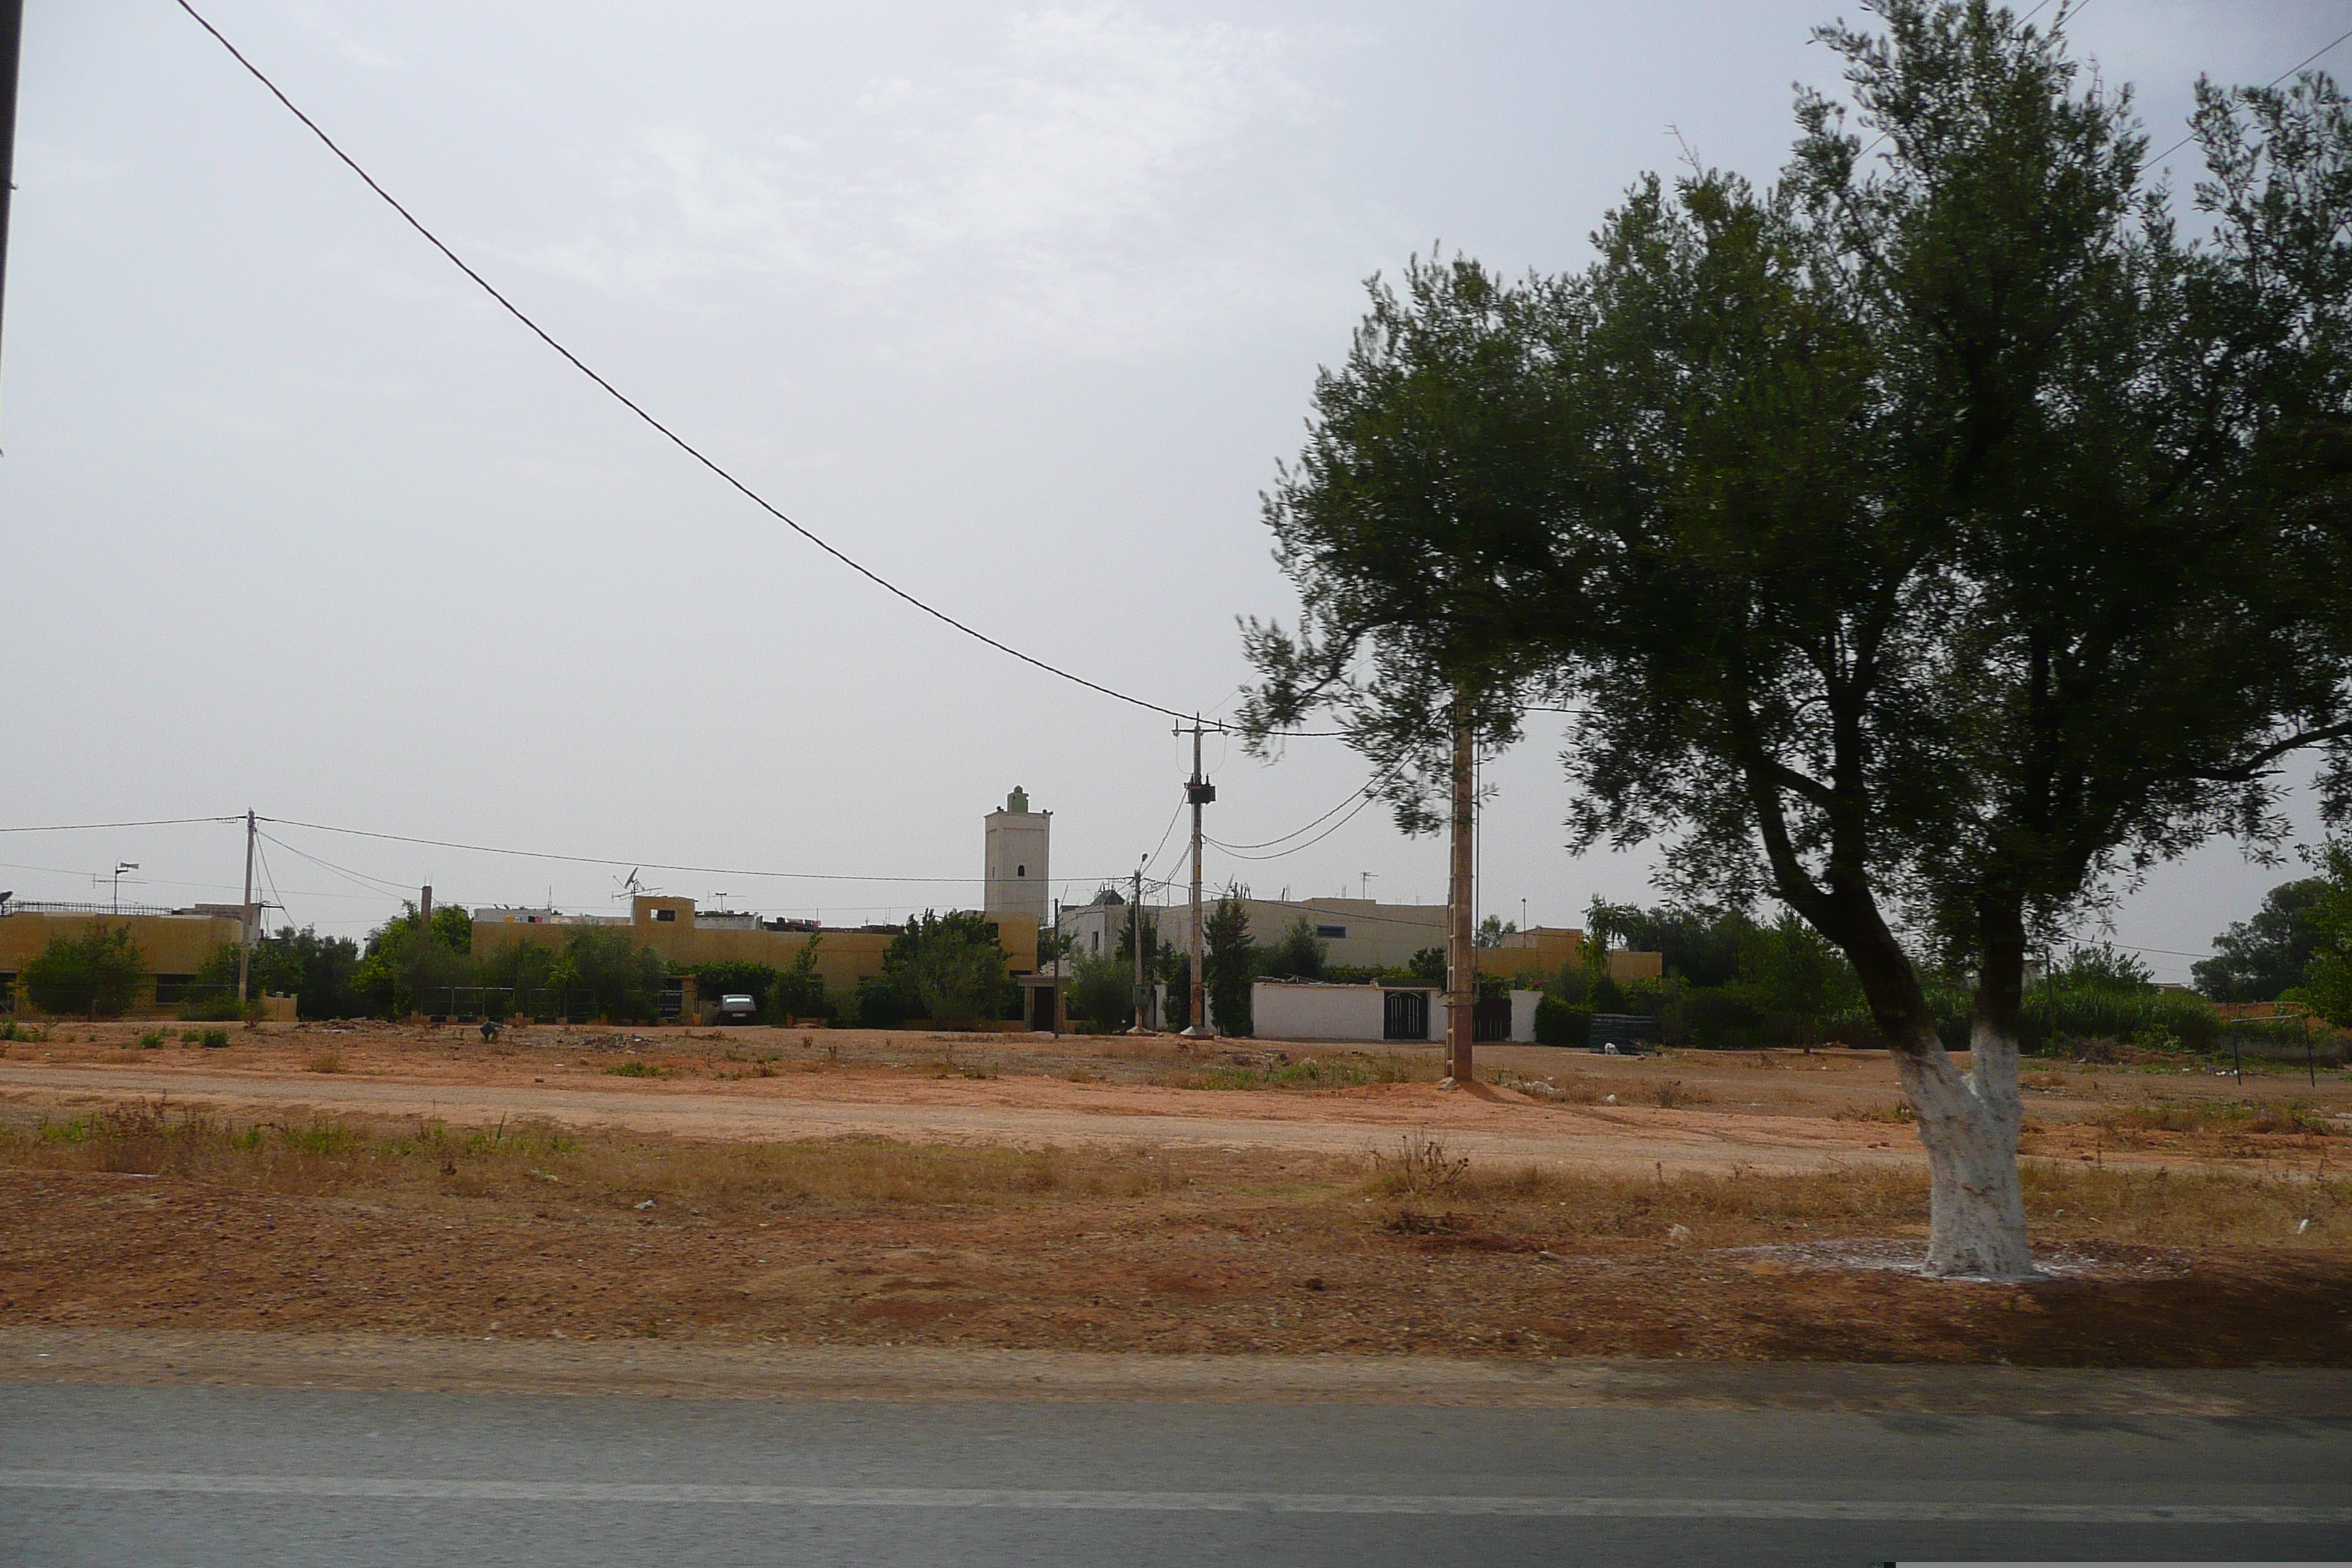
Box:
0, 0, 2352, 978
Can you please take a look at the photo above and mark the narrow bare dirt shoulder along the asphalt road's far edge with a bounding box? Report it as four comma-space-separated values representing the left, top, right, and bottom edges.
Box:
0, 1328, 2352, 1417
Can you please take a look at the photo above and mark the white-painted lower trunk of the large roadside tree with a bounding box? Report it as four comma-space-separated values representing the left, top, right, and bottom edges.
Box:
1896, 1020, 2039, 1279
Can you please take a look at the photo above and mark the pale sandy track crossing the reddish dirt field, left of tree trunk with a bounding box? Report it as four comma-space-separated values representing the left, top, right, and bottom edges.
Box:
0, 1063, 1921, 1171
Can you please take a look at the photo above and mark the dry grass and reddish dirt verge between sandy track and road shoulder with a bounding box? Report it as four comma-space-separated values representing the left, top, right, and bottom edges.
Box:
0, 1105, 2352, 1366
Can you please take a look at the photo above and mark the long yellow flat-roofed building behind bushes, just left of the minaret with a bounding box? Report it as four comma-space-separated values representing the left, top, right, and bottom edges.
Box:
472, 893, 1037, 997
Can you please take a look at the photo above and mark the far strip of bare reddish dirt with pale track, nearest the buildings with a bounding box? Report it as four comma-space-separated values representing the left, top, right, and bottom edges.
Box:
0, 1022, 2352, 1171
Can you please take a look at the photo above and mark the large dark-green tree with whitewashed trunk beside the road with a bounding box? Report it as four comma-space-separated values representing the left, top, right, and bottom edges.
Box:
1246, 0, 2352, 1274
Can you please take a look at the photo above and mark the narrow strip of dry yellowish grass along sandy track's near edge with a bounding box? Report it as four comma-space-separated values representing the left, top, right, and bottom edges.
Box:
0, 1105, 2352, 1253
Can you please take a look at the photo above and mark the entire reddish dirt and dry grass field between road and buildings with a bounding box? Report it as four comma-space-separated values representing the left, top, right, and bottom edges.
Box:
0, 1025, 2352, 1366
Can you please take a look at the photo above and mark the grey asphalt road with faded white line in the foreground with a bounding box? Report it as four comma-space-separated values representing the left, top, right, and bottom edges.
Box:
0, 1382, 2352, 1568
